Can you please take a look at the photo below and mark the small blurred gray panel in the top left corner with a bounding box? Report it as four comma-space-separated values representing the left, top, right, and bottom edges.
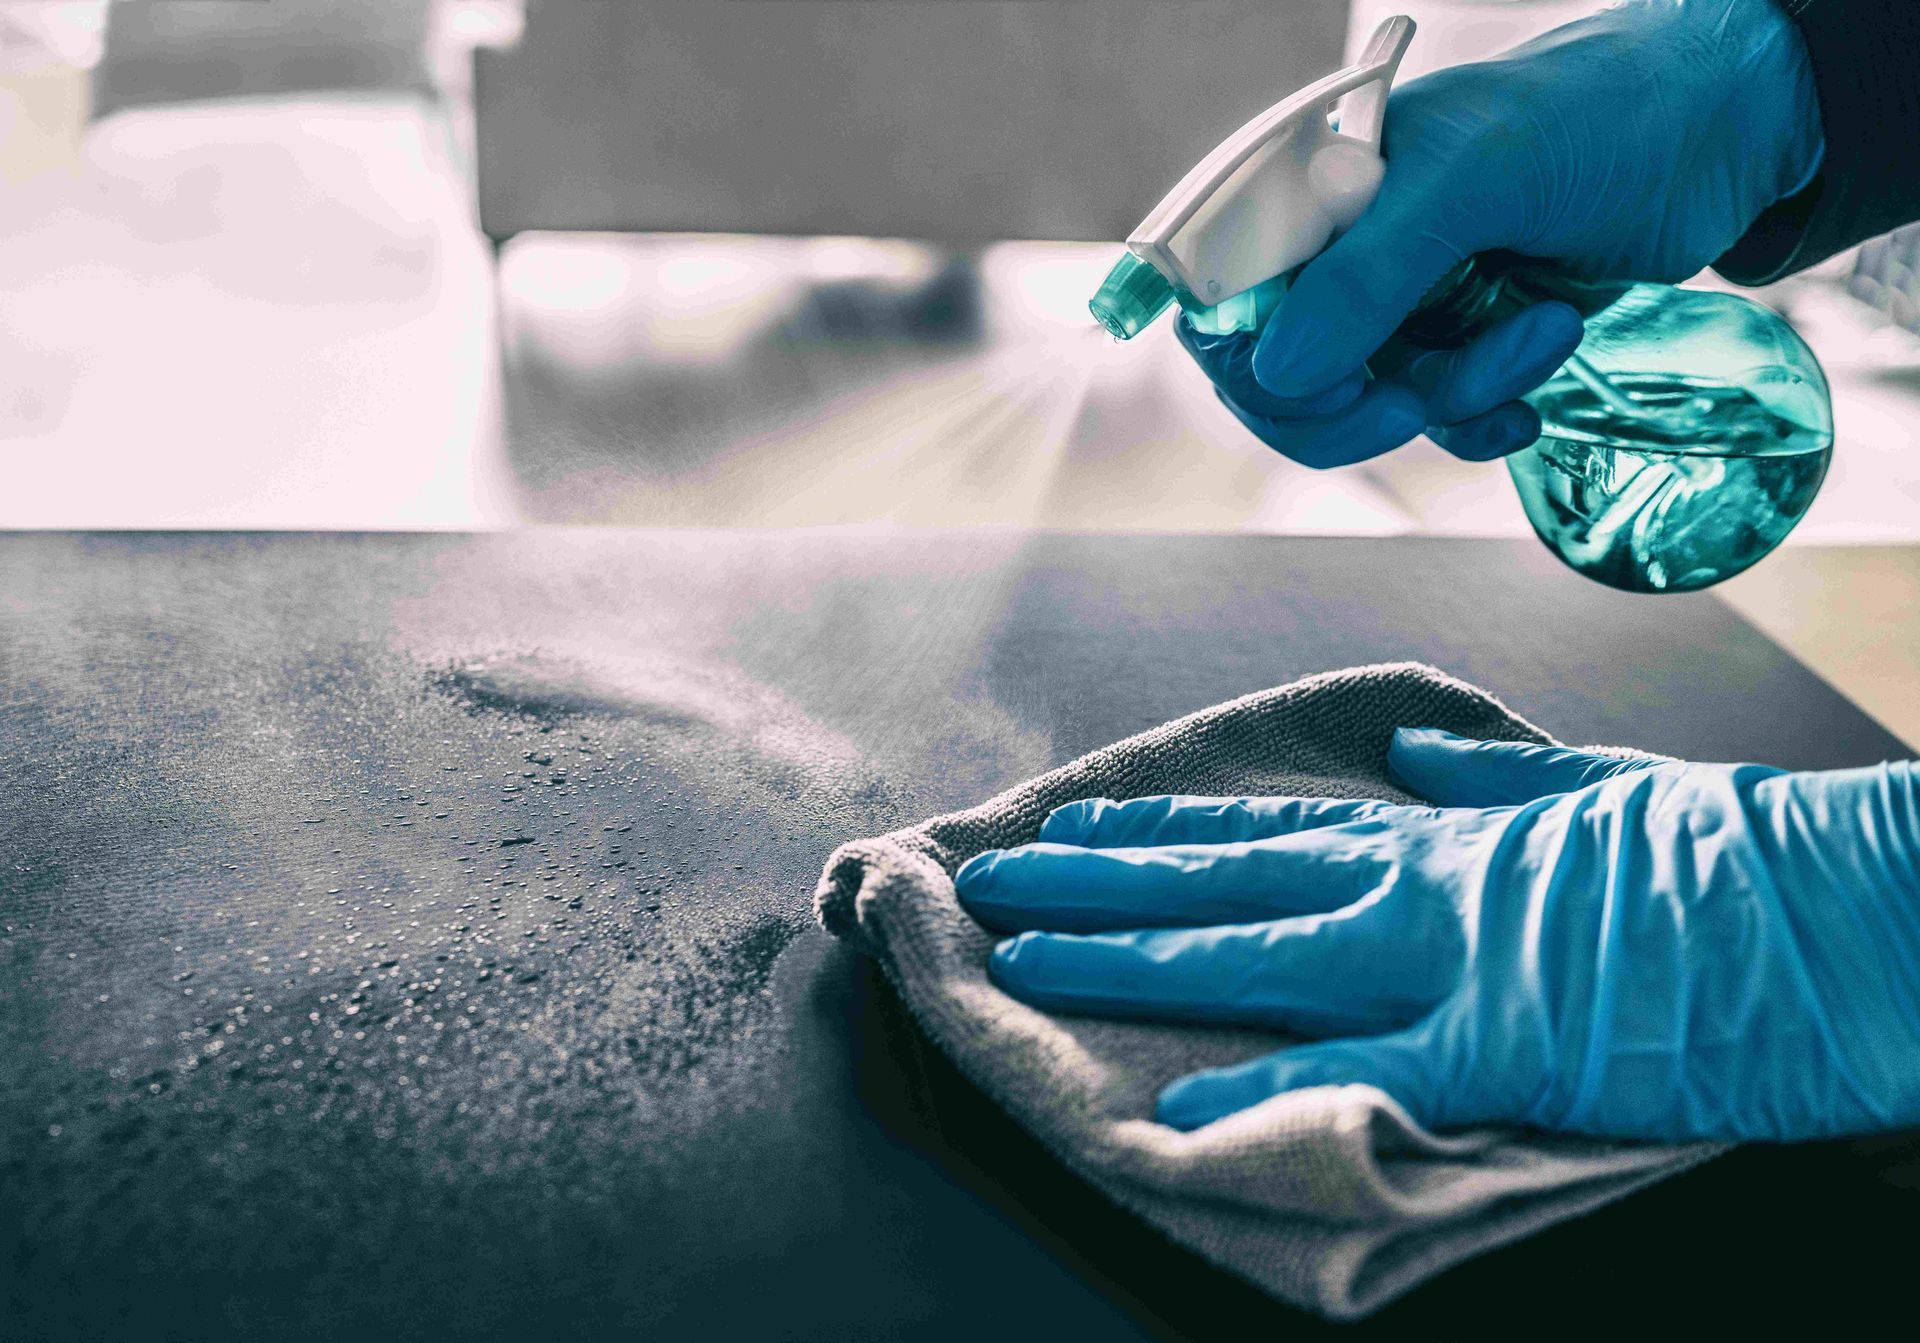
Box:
92, 0, 432, 119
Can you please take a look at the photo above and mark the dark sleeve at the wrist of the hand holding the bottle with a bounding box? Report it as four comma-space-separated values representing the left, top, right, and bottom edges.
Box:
1713, 0, 1920, 284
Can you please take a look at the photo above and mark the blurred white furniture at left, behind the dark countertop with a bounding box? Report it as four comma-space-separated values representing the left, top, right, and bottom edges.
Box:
0, 94, 513, 528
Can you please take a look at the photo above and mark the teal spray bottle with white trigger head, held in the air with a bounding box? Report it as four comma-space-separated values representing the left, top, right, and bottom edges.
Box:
1091, 17, 1834, 592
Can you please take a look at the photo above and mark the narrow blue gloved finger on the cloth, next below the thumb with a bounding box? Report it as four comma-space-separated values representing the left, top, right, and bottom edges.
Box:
1041, 797, 1407, 849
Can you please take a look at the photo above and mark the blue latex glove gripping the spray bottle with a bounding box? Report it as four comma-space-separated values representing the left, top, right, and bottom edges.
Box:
1175, 0, 1826, 467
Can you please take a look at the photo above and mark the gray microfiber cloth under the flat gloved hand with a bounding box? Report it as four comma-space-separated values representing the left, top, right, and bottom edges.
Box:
816, 663, 1720, 1318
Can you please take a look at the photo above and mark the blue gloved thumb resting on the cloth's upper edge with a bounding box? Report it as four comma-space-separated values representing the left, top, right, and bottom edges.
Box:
1386, 728, 1667, 807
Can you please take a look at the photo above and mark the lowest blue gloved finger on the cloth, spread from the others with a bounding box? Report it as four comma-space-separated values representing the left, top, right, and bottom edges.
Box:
1154, 1030, 1446, 1130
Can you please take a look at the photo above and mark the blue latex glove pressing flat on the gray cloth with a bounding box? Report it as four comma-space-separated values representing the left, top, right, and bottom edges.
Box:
954, 730, 1920, 1141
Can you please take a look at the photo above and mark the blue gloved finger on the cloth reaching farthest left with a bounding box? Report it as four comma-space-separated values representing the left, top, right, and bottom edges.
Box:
954, 826, 1384, 932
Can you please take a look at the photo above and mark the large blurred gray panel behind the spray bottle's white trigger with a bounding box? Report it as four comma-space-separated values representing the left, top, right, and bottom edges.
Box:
478, 0, 1346, 242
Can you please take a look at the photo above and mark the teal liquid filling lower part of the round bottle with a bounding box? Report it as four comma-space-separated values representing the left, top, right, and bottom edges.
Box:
1507, 373, 1834, 592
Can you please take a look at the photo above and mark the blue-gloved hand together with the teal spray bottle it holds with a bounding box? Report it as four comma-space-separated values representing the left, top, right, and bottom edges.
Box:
1092, 0, 1834, 592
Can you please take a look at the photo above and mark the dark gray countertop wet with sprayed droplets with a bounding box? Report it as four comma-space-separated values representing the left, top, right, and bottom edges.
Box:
0, 532, 1916, 1339
